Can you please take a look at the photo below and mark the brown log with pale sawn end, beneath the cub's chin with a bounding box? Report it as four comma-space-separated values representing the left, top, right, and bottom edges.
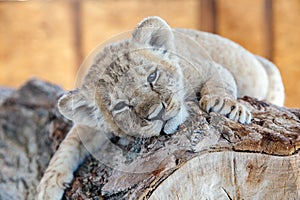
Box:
66, 97, 300, 200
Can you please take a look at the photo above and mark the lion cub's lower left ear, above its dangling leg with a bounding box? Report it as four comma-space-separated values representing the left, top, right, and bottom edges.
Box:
58, 90, 97, 126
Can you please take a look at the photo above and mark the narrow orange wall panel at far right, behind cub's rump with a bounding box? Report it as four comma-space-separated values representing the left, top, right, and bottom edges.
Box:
273, 0, 300, 107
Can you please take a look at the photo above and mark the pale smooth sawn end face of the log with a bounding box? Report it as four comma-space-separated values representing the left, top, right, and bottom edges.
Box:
149, 152, 300, 200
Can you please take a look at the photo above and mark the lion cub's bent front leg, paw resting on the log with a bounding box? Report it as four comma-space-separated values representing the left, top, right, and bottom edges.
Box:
199, 68, 252, 124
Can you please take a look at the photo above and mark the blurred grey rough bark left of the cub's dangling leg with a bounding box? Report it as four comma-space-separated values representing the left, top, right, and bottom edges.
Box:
0, 80, 71, 200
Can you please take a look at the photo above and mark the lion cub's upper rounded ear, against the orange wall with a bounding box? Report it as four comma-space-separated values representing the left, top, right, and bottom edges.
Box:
132, 17, 175, 51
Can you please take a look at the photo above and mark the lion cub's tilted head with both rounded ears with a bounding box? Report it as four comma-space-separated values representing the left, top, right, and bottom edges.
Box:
59, 17, 184, 137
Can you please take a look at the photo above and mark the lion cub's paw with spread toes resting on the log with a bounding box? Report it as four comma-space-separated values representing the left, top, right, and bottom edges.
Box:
199, 95, 252, 124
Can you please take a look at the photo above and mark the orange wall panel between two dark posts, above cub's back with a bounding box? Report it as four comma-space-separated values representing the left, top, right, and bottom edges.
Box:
217, 0, 265, 56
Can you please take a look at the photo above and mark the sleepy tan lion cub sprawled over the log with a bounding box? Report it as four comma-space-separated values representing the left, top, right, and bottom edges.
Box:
37, 17, 284, 199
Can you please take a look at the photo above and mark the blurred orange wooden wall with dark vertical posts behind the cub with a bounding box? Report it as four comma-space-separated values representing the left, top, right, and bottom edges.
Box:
0, 0, 300, 107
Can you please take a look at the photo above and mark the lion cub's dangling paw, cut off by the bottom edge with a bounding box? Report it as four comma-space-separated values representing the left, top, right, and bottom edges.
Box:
36, 170, 73, 200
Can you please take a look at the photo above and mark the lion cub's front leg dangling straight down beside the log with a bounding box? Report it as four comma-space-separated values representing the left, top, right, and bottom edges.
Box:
36, 127, 87, 200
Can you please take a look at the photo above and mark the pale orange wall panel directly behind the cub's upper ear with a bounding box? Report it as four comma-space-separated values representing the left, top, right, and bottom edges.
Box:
82, 0, 200, 55
